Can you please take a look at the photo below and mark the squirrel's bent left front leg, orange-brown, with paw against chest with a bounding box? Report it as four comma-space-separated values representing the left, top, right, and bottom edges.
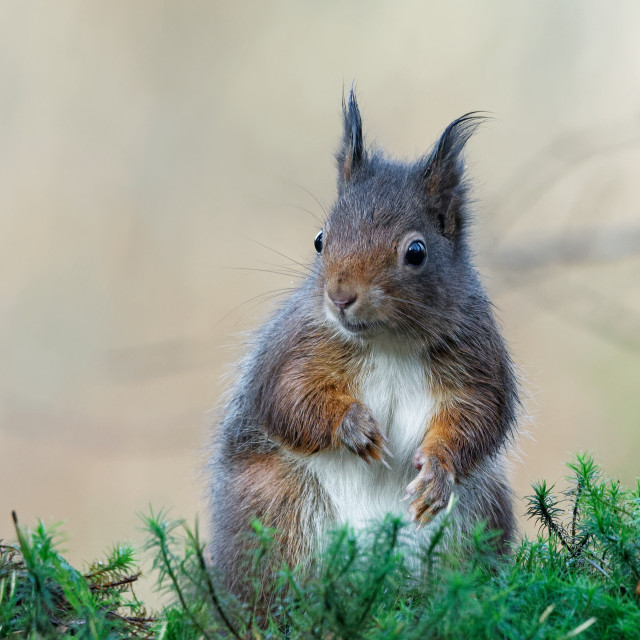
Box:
261, 354, 388, 463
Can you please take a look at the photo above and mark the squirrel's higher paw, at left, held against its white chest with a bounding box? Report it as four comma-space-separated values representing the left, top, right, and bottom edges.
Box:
335, 402, 391, 468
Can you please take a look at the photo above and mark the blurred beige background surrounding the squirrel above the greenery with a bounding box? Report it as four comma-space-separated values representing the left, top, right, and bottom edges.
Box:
0, 0, 640, 596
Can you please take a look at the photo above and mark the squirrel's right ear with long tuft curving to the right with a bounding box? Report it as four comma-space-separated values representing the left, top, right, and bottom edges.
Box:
422, 111, 486, 238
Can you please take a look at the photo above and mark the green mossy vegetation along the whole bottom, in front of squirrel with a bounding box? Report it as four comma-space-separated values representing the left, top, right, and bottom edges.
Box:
0, 456, 640, 640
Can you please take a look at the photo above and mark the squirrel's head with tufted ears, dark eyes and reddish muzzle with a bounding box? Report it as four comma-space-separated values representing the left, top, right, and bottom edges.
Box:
315, 89, 484, 342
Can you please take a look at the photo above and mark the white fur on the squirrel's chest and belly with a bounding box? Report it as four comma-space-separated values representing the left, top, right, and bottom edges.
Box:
309, 345, 435, 528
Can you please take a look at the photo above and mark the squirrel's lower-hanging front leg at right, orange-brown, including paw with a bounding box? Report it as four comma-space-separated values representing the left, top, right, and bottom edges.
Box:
406, 386, 512, 523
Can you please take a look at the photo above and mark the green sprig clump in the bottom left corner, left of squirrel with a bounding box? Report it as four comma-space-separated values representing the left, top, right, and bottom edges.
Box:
0, 512, 154, 640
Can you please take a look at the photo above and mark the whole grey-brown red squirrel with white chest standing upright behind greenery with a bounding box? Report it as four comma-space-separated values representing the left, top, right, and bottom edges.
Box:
208, 91, 519, 590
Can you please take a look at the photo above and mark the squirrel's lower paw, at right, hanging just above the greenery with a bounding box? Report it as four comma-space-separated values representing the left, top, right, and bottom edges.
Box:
404, 449, 455, 524
